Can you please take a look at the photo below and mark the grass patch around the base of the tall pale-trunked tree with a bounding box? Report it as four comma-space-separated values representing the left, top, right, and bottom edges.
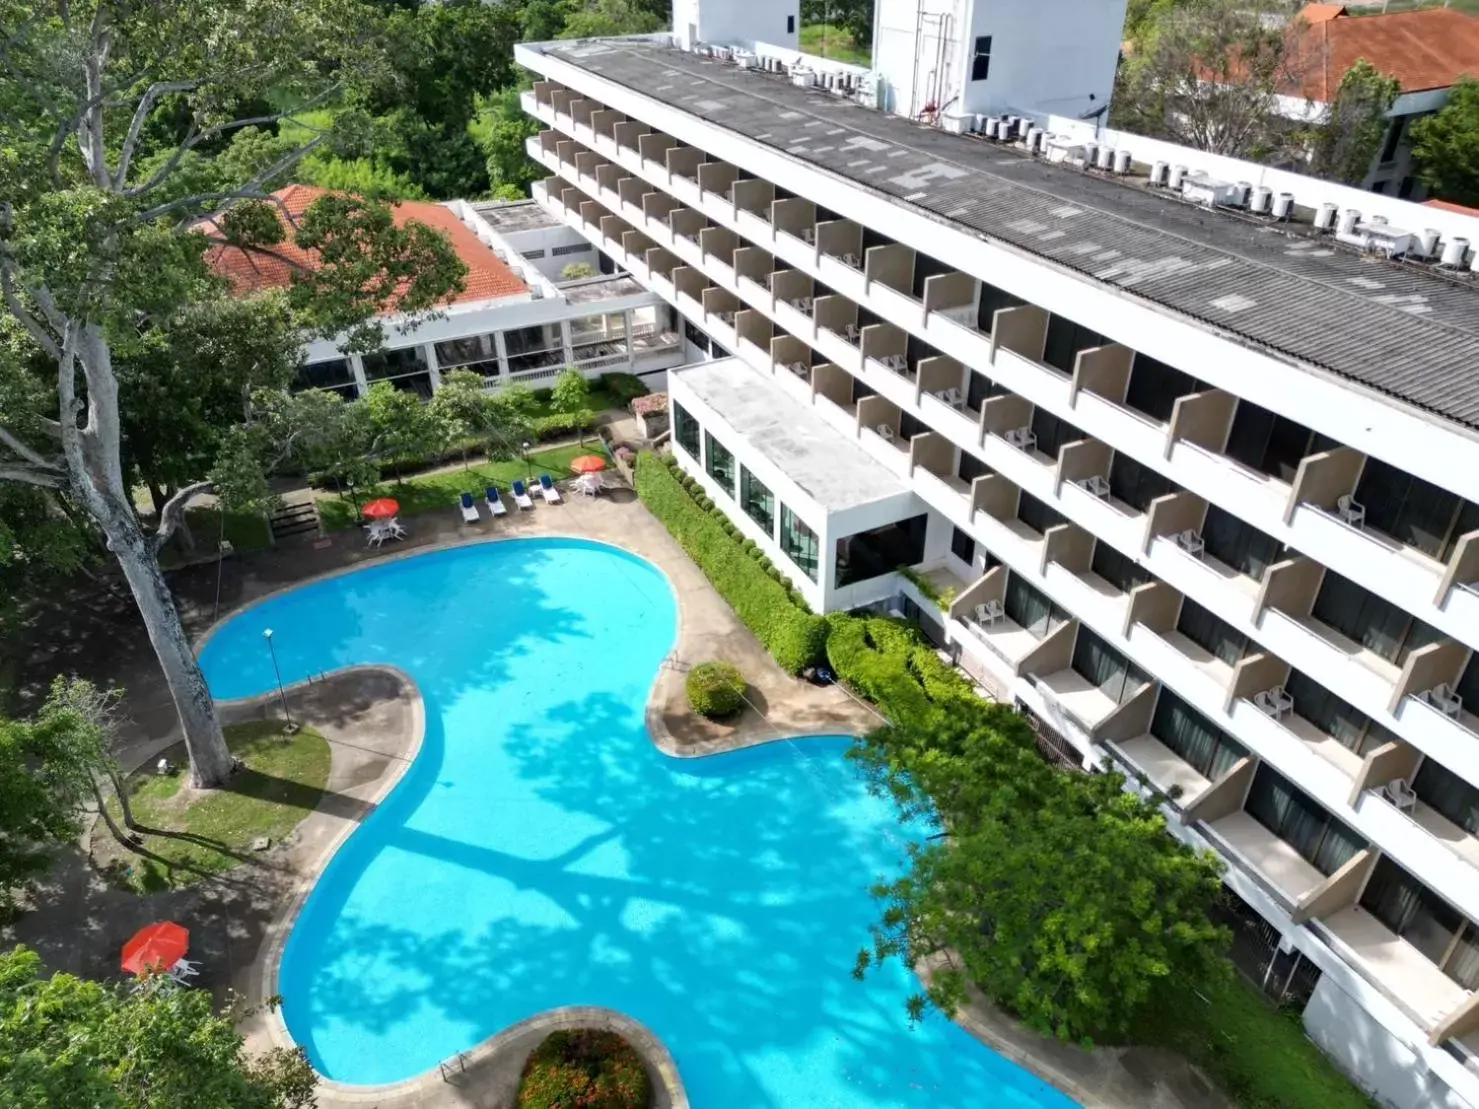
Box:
103, 722, 328, 893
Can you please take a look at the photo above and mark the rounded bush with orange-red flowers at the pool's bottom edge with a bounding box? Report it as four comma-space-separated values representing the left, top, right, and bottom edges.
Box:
518, 1028, 652, 1109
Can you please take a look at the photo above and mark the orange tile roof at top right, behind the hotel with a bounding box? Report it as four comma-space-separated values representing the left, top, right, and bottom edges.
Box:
1288, 4, 1479, 104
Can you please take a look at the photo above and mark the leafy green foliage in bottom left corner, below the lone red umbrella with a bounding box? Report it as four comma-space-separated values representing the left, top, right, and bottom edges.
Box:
0, 948, 317, 1109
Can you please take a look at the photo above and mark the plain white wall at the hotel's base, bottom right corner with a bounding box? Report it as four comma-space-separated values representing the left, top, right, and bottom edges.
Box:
1304, 974, 1476, 1109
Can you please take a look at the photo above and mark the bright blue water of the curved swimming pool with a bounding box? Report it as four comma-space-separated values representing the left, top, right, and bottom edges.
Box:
201, 540, 1075, 1109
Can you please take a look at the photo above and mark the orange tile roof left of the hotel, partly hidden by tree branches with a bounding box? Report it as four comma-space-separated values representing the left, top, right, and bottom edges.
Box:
206, 185, 528, 305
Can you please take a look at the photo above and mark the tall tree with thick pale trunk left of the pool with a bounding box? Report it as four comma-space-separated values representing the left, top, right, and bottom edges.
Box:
0, 0, 461, 787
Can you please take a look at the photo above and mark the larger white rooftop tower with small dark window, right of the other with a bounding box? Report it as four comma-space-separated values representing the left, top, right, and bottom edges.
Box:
869, 0, 1126, 118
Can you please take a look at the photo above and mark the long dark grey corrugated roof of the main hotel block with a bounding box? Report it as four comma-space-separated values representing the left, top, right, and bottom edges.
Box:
535, 40, 1479, 429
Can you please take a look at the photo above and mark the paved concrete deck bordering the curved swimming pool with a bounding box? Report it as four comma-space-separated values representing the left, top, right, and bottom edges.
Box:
0, 491, 1228, 1109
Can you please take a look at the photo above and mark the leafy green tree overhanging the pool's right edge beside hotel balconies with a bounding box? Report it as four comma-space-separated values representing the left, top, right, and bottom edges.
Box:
855, 704, 1228, 1041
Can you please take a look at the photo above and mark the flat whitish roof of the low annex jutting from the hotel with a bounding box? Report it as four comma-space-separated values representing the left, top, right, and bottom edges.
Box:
669, 358, 910, 512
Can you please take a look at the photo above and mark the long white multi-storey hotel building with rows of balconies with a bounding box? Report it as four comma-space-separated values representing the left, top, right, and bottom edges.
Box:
518, 17, 1479, 1109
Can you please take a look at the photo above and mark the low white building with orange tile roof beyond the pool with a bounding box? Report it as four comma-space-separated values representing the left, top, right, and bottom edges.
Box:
207, 185, 683, 398
